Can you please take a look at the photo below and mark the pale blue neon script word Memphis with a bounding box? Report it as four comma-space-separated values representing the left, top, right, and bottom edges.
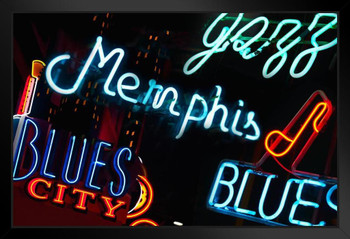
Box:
46, 36, 260, 140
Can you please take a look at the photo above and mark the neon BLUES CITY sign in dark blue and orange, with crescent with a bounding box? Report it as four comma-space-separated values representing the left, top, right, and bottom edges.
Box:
13, 116, 158, 226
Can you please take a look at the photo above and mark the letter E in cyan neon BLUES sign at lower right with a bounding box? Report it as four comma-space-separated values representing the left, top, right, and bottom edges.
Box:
289, 179, 326, 226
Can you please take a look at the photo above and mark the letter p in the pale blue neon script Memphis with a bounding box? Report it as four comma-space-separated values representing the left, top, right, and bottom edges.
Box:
175, 94, 208, 139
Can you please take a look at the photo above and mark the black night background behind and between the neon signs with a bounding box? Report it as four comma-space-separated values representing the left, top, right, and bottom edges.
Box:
13, 13, 337, 226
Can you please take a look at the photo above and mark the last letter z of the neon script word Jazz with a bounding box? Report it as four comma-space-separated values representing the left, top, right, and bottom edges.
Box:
289, 13, 337, 78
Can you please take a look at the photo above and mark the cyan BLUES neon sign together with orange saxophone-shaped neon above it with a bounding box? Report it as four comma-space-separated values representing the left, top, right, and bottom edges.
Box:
208, 91, 337, 226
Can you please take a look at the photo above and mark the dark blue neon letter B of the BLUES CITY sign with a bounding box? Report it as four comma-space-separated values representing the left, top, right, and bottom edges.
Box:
13, 119, 39, 181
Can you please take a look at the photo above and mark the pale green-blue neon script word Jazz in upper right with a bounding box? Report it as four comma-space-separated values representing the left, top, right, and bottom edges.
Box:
183, 13, 337, 78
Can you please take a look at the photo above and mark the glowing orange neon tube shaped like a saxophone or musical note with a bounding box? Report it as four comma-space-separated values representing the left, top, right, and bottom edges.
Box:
265, 102, 331, 157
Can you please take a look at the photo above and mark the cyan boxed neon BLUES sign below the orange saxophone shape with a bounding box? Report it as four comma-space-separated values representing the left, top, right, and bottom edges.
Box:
208, 160, 336, 226
